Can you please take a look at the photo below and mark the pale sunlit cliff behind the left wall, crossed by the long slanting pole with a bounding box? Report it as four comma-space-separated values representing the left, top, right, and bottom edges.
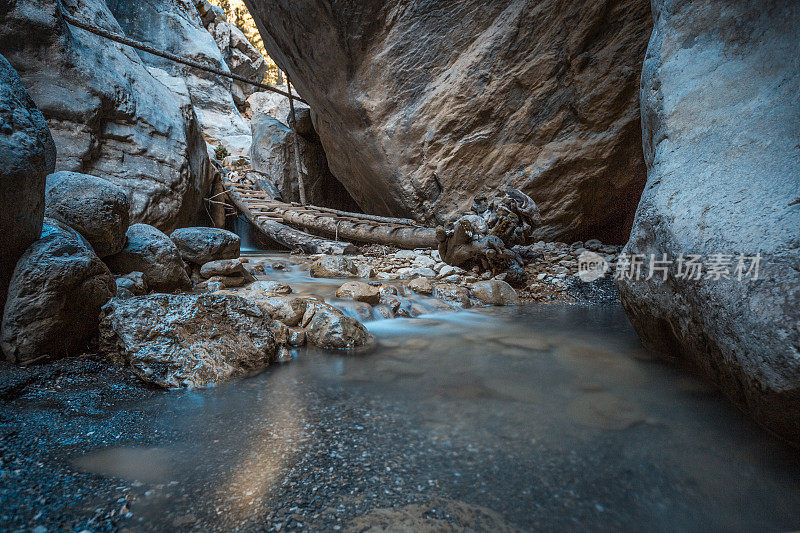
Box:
106, 0, 250, 156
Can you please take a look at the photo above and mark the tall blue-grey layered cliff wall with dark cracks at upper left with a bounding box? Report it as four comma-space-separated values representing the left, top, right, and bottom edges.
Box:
0, 0, 212, 231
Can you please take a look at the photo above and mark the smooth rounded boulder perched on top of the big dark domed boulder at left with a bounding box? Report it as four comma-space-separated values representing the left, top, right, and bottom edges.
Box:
45, 170, 130, 257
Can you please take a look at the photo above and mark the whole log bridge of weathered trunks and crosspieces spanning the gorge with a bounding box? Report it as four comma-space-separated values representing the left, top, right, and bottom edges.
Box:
222, 179, 437, 254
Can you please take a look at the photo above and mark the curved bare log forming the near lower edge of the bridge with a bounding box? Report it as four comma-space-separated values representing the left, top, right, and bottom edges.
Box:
224, 182, 357, 255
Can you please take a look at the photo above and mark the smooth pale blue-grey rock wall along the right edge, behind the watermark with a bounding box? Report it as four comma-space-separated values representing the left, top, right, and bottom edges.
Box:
618, 0, 800, 442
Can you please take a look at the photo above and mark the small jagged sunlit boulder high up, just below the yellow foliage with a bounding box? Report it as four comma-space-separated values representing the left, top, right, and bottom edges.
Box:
206, 20, 267, 107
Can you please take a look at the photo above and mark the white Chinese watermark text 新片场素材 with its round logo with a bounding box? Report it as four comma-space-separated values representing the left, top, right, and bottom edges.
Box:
578, 252, 761, 282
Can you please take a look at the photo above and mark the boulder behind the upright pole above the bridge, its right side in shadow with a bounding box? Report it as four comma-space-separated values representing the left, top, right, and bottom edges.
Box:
250, 110, 359, 211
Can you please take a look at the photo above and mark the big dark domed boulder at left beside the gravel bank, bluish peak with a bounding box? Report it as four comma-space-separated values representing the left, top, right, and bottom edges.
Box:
0, 218, 116, 364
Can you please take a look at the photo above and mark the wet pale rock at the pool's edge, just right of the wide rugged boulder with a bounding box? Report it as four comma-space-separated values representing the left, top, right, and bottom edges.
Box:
303, 301, 373, 350
